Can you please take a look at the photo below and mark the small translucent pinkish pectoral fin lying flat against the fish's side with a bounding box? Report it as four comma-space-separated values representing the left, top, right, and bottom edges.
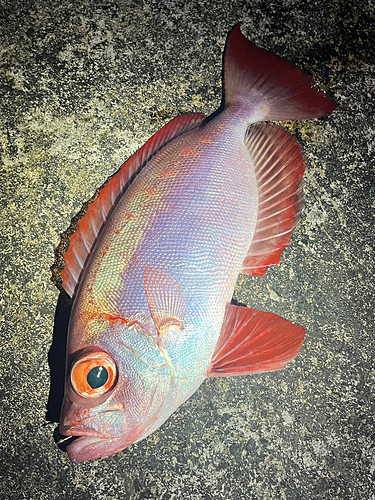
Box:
144, 265, 187, 335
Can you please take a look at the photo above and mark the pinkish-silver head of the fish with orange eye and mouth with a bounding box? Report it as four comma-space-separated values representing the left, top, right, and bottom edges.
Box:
59, 323, 172, 462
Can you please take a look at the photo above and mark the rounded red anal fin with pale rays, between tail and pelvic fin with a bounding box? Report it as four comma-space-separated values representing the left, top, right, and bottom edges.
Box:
241, 124, 305, 276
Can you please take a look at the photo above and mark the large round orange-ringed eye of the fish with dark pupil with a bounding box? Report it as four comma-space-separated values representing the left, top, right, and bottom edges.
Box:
70, 351, 117, 398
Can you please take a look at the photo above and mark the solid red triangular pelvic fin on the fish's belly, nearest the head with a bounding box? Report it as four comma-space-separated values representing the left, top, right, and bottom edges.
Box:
208, 304, 305, 377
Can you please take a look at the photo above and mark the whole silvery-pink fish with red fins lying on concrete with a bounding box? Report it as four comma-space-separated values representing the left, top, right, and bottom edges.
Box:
54, 23, 337, 463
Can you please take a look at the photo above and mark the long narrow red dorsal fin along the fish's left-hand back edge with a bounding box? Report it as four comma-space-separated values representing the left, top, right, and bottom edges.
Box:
61, 113, 206, 297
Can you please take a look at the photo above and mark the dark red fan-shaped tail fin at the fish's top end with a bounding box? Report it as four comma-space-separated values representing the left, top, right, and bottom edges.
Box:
224, 23, 337, 121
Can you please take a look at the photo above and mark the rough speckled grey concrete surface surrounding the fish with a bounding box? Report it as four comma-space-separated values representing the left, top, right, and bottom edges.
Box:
0, 0, 375, 500
